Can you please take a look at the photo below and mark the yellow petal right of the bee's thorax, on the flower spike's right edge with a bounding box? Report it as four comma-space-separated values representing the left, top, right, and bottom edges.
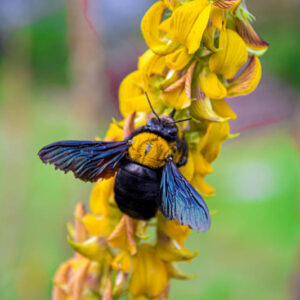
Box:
198, 122, 230, 163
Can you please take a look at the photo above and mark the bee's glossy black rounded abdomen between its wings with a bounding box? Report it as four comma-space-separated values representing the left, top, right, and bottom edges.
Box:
114, 161, 161, 220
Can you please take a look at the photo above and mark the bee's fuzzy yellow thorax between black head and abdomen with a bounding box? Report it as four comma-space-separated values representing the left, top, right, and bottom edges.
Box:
129, 132, 175, 169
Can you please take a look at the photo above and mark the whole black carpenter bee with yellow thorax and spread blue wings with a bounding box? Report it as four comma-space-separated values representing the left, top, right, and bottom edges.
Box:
38, 94, 210, 231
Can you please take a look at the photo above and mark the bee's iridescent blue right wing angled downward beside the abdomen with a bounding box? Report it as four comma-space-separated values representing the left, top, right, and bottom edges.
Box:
159, 160, 210, 231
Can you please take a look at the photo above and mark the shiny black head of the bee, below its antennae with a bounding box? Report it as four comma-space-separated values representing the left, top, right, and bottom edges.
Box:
144, 117, 178, 142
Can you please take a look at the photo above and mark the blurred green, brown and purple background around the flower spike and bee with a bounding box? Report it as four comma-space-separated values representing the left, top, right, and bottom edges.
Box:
0, 0, 300, 300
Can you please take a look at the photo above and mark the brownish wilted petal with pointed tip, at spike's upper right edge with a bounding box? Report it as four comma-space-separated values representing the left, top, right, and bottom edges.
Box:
235, 18, 269, 55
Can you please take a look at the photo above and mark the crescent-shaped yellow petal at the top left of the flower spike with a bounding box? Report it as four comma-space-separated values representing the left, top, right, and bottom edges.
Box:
141, 1, 179, 55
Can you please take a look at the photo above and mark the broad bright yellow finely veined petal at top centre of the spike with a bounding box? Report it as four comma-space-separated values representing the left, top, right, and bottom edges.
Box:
161, 0, 210, 54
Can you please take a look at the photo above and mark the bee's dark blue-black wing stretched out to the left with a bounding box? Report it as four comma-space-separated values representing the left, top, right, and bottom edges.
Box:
38, 141, 128, 182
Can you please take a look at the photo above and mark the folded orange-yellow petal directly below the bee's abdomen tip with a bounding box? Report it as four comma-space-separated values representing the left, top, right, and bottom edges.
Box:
108, 215, 136, 255
